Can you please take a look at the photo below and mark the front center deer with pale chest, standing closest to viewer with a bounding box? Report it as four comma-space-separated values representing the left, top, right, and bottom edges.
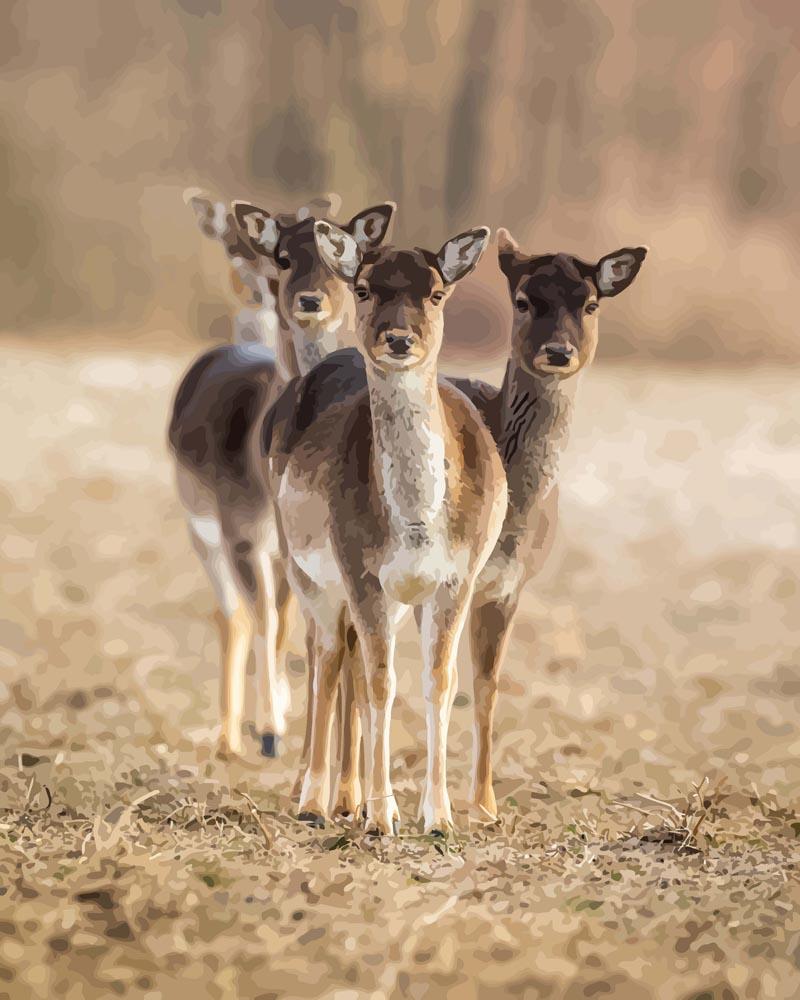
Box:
262, 220, 507, 835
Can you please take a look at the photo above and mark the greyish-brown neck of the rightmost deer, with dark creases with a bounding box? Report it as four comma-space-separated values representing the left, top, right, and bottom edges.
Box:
498, 359, 576, 522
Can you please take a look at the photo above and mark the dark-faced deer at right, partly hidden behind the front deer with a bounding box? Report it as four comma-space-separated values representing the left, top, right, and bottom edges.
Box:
456, 229, 647, 821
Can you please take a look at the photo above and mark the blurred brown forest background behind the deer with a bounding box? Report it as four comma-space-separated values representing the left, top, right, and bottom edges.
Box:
0, 0, 800, 364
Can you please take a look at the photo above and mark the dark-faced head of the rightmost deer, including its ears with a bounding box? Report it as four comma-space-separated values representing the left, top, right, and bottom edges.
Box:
497, 229, 647, 378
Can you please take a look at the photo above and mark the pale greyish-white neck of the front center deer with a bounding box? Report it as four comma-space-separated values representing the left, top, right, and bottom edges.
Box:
367, 363, 447, 545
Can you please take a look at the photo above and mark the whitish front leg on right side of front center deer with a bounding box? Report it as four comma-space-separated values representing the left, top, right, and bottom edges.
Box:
420, 587, 469, 833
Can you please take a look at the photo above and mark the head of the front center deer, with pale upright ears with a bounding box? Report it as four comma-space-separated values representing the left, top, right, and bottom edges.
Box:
314, 221, 489, 370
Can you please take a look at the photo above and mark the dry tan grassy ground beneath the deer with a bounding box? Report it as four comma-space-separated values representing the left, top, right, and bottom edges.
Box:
0, 337, 800, 1000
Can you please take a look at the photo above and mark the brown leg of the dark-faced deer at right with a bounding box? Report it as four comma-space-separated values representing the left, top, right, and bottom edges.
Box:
470, 596, 516, 822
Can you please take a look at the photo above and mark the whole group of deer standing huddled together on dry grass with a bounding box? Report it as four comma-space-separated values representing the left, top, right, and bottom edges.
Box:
169, 192, 646, 834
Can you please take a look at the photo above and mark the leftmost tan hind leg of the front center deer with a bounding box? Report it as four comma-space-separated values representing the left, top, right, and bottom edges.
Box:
298, 623, 344, 827
